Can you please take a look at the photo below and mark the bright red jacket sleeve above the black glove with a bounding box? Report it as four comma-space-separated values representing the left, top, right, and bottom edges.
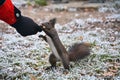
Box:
0, 0, 16, 25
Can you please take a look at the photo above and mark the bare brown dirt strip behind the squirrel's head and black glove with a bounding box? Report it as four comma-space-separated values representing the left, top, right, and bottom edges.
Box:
21, 7, 111, 24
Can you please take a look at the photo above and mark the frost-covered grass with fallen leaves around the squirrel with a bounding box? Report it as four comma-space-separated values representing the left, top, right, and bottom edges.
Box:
0, 14, 120, 80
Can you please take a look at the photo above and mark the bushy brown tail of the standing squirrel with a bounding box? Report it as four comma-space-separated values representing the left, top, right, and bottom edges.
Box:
68, 43, 90, 61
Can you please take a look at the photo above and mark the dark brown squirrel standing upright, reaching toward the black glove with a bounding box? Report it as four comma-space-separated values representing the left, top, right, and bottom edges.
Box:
39, 19, 90, 70
